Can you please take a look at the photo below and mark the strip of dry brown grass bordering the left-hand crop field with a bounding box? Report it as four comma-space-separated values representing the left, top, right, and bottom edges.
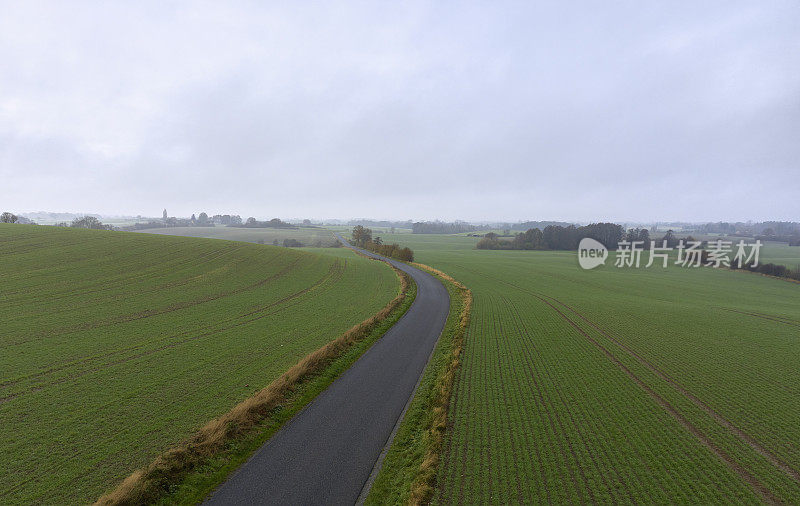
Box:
95, 262, 409, 505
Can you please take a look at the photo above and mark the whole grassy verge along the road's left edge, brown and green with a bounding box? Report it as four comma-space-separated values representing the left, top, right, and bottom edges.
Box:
96, 256, 416, 505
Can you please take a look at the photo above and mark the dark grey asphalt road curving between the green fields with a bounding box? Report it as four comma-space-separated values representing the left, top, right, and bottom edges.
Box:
206, 237, 450, 505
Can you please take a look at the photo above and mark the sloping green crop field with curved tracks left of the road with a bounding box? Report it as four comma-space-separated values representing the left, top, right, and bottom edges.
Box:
0, 225, 398, 504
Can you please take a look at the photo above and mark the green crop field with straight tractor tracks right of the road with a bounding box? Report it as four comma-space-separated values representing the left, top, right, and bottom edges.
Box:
368, 235, 800, 504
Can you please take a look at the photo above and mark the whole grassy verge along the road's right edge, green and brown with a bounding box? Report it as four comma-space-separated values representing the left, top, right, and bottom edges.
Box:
366, 263, 472, 504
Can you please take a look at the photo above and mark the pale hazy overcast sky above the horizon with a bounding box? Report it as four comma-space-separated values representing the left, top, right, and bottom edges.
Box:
0, 0, 800, 221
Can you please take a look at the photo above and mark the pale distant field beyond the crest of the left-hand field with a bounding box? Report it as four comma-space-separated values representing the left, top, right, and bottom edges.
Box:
137, 226, 337, 247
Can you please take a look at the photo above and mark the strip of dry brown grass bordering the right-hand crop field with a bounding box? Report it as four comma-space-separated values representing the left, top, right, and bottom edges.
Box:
408, 263, 472, 505
